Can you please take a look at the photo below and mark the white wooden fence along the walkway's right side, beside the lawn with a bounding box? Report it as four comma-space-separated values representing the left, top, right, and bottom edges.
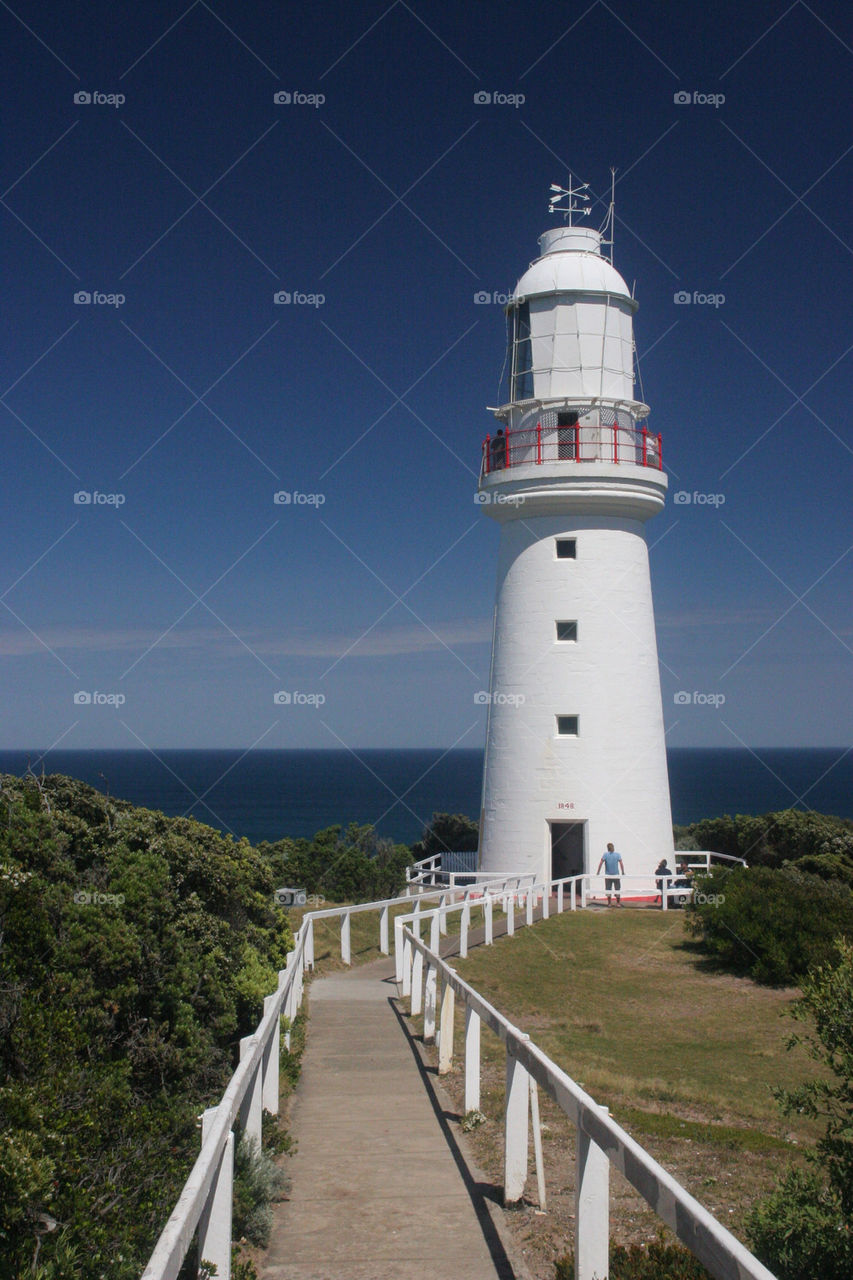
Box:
400, 926, 775, 1280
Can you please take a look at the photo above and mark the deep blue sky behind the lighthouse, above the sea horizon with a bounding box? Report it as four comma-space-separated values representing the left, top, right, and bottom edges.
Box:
0, 0, 853, 750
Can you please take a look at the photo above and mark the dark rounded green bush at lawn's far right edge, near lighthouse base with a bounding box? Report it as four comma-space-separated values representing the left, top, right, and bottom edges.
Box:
686, 867, 853, 986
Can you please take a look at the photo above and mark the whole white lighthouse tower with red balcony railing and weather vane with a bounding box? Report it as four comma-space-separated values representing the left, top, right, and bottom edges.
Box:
478, 183, 672, 878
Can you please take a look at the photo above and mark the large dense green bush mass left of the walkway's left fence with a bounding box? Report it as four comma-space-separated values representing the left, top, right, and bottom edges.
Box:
0, 776, 293, 1280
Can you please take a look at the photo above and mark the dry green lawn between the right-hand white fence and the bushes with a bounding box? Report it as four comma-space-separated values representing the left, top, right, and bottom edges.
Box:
453, 909, 813, 1142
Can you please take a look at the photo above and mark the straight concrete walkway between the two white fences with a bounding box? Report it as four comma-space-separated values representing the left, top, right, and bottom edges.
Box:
259, 959, 524, 1280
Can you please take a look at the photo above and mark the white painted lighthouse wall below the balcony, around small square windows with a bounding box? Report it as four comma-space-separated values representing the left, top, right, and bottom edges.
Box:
480, 504, 672, 877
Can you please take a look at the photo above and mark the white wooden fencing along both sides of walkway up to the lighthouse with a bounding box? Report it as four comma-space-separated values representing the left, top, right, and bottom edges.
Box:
141, 854, 758, 1280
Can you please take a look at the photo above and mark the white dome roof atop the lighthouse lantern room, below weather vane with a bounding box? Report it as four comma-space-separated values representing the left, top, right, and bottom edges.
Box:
514, 227, 637, 311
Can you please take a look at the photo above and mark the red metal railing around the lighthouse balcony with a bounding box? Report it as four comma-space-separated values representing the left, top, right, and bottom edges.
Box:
482, 422, 663, 475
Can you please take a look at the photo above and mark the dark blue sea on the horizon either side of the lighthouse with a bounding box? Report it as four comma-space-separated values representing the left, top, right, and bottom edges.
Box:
0, 748, 853, 844
